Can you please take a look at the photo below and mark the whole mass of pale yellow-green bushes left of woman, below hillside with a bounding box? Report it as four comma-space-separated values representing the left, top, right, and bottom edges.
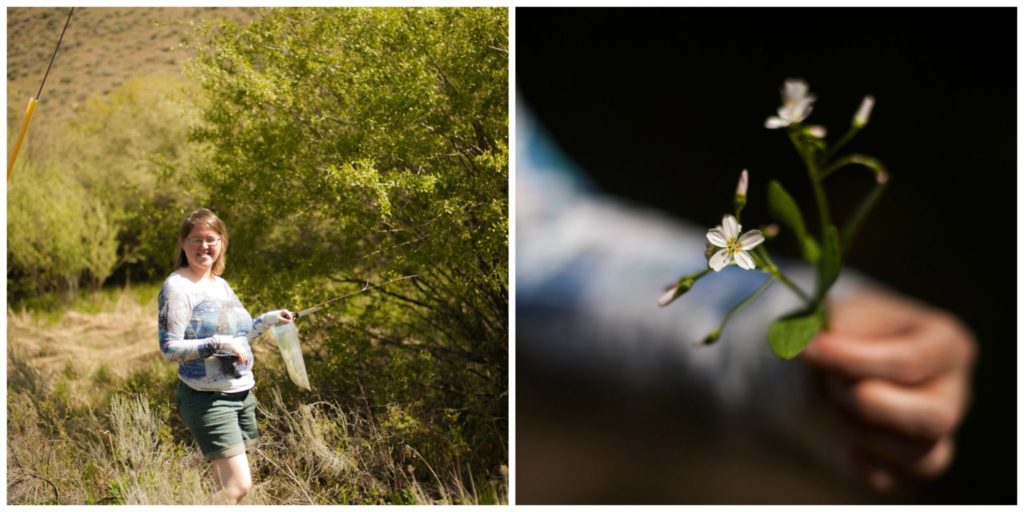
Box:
7, 76, 202, 302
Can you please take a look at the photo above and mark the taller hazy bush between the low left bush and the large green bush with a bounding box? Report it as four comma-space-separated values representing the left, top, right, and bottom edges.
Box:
55, 75, 203, 281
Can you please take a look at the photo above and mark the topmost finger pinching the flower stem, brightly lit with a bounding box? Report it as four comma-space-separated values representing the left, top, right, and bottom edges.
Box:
804, 314, 972, 384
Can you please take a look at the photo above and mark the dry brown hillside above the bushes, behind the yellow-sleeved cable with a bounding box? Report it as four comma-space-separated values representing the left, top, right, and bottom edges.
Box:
7, 7, 255, 130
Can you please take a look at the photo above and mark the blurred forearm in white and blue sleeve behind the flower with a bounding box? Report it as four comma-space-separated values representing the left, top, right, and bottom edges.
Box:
517, 192, 872, 417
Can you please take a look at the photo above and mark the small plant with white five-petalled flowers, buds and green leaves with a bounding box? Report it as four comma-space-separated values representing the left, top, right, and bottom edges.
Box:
658, 80, 889, 359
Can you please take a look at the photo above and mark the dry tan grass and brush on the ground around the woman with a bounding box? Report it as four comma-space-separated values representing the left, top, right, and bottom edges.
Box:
7, 284, 508, 505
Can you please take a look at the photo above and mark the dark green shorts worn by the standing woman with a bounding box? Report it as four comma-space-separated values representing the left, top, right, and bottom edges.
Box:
174, 381, 259, 461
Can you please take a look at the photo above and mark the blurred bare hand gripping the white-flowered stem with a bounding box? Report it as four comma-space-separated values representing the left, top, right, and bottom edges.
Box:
803, 290, 977, 493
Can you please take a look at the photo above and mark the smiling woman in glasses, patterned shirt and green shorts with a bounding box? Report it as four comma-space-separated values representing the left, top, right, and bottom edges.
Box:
158, 208, 292, 504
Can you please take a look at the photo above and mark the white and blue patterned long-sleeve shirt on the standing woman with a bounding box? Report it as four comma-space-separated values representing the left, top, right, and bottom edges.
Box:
157, 271, 273, 392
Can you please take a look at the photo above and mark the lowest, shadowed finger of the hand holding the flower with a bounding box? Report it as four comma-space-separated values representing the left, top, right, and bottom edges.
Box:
853, 421, 953, 478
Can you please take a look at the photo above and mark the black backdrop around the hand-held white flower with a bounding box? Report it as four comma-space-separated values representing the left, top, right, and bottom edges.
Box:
515, 8, 1017, 504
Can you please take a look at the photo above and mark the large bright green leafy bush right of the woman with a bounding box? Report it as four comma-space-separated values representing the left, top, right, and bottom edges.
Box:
193, 8, 508, 487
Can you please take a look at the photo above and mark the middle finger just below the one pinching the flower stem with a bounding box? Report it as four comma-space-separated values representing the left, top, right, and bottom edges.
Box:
835, 377, 966, 440
